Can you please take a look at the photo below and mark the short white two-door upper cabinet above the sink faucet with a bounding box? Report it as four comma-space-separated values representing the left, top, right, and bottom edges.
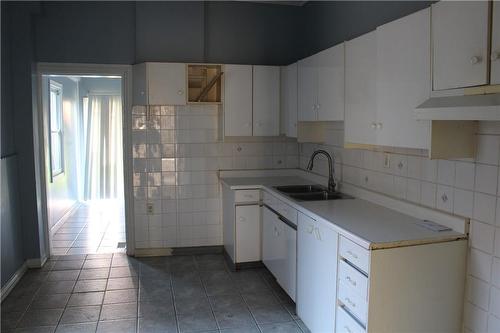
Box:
298, 43, 344, 121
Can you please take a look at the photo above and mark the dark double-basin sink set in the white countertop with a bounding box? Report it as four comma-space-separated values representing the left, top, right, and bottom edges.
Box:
274, 185, 353, 201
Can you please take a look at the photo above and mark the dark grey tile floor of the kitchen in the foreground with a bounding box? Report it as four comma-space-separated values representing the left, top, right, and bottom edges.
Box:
1, 253, 307, 333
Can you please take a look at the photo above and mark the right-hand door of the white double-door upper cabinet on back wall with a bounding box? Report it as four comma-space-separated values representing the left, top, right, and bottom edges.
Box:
253, 66, 280, 136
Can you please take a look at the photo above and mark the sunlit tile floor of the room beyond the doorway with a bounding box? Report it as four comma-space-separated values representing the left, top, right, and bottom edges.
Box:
51, 200, 126, 255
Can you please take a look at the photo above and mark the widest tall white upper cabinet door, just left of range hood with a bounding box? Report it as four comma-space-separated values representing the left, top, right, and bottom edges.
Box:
377, 8, 430, 149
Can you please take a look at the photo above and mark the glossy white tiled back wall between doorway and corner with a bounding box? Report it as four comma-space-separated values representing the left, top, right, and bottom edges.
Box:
132, 106, 299, 248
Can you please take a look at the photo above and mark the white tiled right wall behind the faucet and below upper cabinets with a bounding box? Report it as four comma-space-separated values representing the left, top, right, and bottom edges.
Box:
299, 122, 500, 333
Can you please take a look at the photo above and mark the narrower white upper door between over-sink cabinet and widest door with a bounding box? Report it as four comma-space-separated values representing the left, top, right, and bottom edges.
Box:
344, 31, 377, 144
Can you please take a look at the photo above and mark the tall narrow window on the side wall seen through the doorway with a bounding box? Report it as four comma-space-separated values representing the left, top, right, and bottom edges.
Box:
49, 81, 64, 178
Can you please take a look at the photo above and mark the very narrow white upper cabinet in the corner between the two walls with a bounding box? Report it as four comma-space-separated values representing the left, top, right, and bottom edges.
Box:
281, 63, 298, 138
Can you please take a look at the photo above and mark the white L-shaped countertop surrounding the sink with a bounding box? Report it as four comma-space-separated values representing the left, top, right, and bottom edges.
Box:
221, 176, 465, 249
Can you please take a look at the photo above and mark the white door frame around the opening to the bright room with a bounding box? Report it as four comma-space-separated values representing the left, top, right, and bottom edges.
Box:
33, 62, 135, 256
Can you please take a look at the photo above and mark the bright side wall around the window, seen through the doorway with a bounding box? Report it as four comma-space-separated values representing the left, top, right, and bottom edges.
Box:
43, 77, 79, 229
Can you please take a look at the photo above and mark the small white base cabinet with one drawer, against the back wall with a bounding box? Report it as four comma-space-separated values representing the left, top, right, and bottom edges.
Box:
222, 186, 262, 269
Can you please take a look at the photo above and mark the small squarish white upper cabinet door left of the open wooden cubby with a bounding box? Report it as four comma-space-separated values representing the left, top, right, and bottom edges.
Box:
146, 63, 186, 105
